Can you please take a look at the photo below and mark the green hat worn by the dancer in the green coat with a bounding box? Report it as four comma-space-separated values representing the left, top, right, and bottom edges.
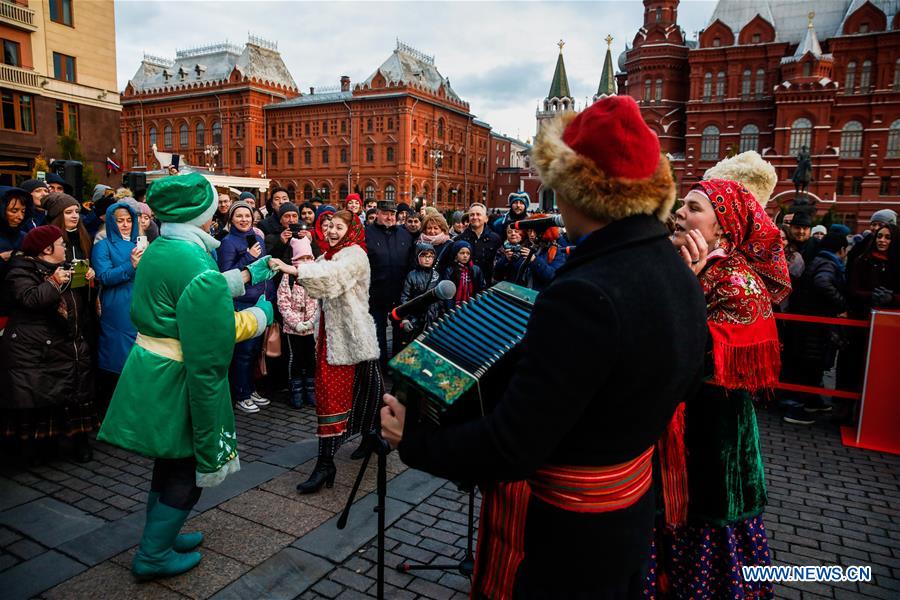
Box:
147, 173, 217, 224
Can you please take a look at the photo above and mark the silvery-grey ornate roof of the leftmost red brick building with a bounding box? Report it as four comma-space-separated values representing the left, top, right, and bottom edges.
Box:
130, 35, 297, 92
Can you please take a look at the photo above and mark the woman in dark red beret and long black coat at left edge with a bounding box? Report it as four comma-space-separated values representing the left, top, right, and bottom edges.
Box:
0, 225, 97, 463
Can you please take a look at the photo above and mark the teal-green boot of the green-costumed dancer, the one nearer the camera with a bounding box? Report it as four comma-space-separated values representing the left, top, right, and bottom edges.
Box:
131, 494, 200, 580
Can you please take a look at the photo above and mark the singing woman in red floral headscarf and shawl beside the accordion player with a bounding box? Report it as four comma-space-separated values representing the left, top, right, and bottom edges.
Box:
648, 179, 791, 598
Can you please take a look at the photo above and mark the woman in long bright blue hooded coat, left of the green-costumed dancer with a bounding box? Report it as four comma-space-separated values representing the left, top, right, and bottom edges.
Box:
94, 202, 146, 413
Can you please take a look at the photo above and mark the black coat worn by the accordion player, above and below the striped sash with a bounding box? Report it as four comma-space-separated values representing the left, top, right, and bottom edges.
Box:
399, 215, 707, 598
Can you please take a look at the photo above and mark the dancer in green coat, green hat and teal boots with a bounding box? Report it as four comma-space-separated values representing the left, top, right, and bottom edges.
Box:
98, 174, 275, 579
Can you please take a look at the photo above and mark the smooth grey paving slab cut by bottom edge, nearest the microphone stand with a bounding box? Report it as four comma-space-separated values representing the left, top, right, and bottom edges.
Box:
214, 548, 332, 600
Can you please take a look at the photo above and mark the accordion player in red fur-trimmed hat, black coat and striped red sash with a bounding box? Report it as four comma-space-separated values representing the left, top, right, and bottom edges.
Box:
381, 96, 706, 600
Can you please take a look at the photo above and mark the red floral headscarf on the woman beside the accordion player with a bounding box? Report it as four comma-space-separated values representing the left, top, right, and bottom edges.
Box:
692, 179, 791, 304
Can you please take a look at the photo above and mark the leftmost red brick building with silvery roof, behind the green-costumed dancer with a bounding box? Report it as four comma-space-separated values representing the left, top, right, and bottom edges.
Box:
121, 36, 299, 177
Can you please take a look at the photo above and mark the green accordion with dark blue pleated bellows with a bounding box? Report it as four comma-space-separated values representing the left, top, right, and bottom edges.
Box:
390, 282, 537, 425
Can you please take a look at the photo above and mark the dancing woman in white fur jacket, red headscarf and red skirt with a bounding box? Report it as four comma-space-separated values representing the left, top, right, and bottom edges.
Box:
278, 210, 383, 494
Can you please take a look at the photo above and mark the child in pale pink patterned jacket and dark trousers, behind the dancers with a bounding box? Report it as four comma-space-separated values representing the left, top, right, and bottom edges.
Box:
278, 238, 319, 408
